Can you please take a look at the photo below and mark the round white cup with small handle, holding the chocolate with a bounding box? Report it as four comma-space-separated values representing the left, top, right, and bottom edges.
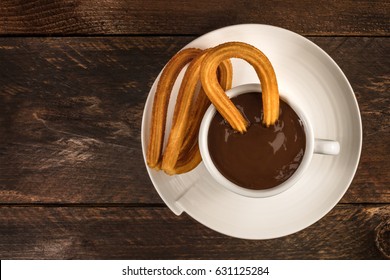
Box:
199, 84, 340, 198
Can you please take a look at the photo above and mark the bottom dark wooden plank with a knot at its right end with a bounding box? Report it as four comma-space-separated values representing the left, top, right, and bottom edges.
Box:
0, 205, 390, 259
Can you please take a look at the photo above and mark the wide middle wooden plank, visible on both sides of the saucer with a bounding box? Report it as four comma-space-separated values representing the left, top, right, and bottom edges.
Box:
0, 37, 390, 203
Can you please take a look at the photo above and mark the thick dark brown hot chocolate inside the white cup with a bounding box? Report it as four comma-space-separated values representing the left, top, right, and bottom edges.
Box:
208, 93, 306, 189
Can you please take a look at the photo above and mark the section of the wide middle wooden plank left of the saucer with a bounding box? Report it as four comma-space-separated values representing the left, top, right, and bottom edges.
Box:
0, 38, 177, 203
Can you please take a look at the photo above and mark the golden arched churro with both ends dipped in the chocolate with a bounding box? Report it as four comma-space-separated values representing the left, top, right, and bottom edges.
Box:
201, 42, 279, 133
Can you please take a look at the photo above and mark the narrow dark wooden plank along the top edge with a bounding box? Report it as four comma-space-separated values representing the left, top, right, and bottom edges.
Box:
0, 0, 390, 36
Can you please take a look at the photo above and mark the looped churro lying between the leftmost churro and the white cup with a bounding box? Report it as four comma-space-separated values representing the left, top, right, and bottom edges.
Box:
161, 50, 232, 174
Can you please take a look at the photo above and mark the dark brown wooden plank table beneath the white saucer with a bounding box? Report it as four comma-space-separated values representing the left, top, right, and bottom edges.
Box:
0, 0, 390, 259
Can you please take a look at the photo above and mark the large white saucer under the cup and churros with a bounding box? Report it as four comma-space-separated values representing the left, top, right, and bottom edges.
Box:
142, 24, 362, 239
